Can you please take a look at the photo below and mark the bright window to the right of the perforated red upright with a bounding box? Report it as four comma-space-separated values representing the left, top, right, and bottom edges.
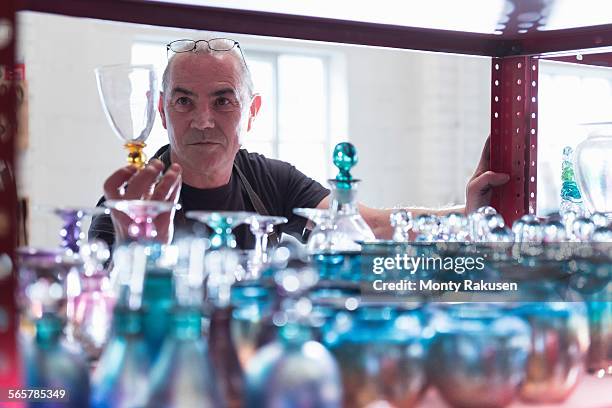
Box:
537, 61, 612, 215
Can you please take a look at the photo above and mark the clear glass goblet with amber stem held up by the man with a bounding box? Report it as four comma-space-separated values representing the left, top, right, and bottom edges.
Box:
95, 64, 159, 168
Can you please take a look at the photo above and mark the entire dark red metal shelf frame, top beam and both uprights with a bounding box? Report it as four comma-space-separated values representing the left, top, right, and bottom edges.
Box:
0, 0, 612, 386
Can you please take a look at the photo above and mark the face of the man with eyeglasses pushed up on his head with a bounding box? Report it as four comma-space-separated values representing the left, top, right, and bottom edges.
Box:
159, 52, 260, 173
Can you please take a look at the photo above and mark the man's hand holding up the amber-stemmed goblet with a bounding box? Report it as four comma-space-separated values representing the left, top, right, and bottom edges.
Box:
104, 159, 181, 243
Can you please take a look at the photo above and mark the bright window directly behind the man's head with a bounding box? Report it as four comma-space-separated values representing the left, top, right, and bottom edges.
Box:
132, 42, 333, 185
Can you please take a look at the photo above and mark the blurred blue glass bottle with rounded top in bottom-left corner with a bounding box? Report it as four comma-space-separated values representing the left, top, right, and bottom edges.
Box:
23, 313, 90, 408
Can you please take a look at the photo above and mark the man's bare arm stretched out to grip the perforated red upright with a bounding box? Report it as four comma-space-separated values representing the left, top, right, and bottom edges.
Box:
317, 138, 510, 239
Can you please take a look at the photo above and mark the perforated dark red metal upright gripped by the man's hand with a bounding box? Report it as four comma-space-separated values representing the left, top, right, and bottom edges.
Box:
491, 57, 538, 224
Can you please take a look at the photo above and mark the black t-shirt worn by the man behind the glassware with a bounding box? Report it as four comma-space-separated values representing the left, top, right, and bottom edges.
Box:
89, 146, 329, 249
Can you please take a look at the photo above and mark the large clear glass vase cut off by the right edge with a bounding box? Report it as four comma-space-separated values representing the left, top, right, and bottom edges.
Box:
575, 123, 612, 220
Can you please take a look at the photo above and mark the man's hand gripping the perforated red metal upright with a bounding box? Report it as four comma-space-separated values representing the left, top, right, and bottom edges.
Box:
465, 136, 510, 215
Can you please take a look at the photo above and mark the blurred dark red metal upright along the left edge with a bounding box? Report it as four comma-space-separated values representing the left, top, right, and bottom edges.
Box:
0, 0, 19, 388
